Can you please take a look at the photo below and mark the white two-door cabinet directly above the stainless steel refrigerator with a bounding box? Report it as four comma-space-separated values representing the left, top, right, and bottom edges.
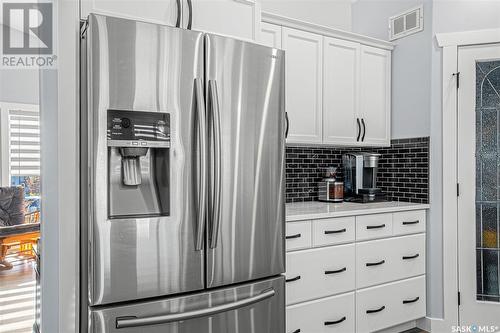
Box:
81, 0, 260, 40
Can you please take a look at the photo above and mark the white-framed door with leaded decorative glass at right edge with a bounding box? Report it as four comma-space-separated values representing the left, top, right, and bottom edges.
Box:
458, 44, 500, 329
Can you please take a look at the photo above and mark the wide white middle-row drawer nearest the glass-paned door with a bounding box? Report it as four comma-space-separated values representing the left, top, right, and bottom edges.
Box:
356, 234, 425, 288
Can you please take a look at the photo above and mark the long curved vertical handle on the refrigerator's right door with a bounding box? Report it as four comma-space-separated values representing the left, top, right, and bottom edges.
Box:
208, 80, 222, 249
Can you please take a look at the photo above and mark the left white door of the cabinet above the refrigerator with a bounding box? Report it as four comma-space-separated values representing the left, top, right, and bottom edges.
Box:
81, 0, 178, 26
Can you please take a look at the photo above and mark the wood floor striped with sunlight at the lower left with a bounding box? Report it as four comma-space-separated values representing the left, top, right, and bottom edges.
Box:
0, 254, 35, 333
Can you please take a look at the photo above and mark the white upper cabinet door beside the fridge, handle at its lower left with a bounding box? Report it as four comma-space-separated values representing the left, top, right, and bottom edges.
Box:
282, 27, 323, 143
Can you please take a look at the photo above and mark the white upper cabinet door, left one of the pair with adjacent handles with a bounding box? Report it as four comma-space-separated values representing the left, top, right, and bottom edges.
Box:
323, 37, 361, 145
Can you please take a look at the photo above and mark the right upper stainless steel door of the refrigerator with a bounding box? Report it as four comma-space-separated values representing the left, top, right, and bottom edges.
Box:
205, 35, 285, 287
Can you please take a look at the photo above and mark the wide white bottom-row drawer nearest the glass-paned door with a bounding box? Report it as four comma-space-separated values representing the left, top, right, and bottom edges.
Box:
356, 276, 426, 333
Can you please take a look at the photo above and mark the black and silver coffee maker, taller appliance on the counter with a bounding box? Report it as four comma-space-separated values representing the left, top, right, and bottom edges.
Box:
342, 152, 387, 203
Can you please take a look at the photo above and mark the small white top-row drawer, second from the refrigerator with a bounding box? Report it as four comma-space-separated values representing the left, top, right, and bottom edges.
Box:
312, 216, 356, 246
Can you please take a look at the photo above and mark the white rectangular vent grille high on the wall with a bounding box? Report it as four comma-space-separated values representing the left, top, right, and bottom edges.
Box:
389, 6, 424, 40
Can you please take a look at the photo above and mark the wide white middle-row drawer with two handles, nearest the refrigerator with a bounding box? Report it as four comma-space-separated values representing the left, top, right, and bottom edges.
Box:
286, 244, 355, 304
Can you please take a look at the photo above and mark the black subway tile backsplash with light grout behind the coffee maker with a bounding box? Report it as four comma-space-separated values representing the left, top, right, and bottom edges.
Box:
286, 137, 429, 203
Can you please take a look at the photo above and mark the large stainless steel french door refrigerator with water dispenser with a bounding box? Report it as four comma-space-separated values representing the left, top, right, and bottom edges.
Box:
80, 14, 286, 333
